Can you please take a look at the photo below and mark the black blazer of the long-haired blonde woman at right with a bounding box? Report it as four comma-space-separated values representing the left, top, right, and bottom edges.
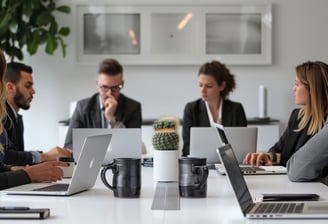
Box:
269, 109, 313, 166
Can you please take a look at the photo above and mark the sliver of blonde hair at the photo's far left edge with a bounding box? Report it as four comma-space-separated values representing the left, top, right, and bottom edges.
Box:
0, 49, 7, 151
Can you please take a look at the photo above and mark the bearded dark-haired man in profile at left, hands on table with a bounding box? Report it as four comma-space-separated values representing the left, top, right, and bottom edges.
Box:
0, 62, 72, 166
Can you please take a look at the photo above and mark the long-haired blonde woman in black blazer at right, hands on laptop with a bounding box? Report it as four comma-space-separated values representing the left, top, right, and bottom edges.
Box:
244, 61, 328, 166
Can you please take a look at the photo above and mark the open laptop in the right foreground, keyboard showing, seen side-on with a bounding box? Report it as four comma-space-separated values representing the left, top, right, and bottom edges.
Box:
217, 144, 328, 219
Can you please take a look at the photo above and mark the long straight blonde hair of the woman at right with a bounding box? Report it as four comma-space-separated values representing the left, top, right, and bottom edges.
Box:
296, 61, 328, 135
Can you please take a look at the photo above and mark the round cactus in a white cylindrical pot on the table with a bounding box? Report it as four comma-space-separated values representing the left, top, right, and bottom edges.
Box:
152, 116, 179, 182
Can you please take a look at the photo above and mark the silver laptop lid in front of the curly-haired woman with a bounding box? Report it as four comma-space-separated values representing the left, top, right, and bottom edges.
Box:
190, 126, 257, 165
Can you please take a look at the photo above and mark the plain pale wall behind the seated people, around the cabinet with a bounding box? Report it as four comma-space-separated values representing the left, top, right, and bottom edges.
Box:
22, 0, 328, 150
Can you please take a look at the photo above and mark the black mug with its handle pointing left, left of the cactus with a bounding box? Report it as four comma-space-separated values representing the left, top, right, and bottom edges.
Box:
100, 158, 141, 198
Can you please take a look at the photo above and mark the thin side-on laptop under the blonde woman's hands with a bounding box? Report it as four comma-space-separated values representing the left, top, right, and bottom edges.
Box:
214, 125, 287, 175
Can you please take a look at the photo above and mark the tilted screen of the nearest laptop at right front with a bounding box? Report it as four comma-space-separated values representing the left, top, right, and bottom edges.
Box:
218, 144, 253, 215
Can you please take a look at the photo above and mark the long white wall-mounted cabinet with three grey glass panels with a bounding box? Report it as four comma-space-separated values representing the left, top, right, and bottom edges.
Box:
76, 4, 272, 65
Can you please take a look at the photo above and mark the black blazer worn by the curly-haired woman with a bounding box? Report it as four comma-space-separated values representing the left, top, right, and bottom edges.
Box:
182, 99, 247, 156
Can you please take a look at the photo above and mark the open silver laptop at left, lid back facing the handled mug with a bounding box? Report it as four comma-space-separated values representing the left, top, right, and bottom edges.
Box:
0, 134, 112, 196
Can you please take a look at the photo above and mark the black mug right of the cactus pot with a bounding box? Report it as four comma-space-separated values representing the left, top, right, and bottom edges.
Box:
179, 157, 208, 197
